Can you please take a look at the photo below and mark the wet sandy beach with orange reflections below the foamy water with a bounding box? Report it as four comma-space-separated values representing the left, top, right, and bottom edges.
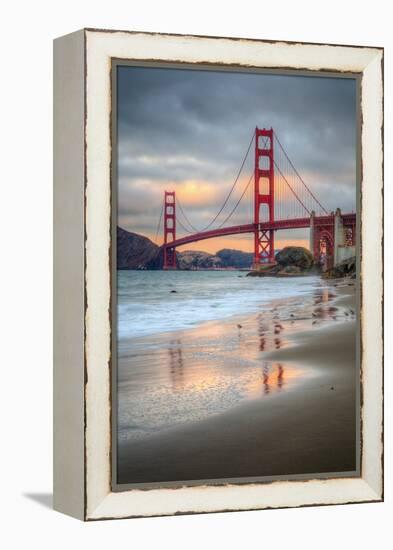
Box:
118, 280, 358, 483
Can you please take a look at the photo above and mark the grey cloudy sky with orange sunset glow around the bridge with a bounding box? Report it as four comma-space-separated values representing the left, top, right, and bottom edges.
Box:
118, 66, 356, 252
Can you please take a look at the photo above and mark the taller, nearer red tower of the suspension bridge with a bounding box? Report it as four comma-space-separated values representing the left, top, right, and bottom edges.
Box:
254, 127, 274, 268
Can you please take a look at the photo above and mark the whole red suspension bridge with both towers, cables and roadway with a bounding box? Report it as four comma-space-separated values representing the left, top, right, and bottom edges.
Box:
157, 127, 356, 269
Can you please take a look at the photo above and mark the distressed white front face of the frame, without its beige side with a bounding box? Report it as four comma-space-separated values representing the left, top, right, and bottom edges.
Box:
86, 31, 382, 519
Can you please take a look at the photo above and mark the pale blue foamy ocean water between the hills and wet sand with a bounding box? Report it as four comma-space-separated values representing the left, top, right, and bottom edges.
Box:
117, 271, 320, 344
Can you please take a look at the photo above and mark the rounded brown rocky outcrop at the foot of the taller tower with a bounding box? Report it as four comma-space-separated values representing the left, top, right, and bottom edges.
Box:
247, 246, 318, 277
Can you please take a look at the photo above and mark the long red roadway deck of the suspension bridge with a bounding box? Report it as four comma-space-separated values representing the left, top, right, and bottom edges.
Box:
163, 213, 356, 248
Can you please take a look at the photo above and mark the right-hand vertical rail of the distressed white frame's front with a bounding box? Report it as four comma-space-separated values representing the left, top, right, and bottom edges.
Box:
361, 51, 383, 495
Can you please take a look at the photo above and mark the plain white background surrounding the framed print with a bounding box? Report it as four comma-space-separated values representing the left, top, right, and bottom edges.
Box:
0, 0, 393, 550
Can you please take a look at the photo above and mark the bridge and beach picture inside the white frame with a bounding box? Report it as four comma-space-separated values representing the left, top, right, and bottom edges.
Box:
112, 62, 360, 490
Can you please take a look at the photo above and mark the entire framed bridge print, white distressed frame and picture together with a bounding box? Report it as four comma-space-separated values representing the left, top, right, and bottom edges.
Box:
54, 29, 383, 520
